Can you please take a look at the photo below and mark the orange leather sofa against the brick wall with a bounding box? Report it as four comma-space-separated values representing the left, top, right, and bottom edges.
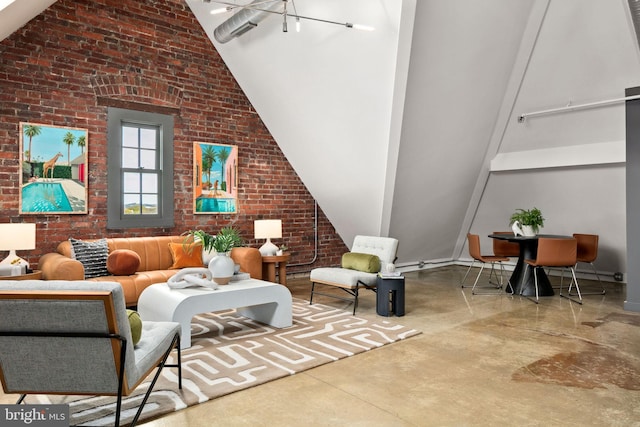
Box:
38, 236, 262, 306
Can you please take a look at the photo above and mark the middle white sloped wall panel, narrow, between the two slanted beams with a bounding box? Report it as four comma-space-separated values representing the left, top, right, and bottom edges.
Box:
390, 0, 532, 265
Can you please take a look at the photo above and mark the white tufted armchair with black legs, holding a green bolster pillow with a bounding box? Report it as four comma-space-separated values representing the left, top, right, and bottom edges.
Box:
309, 236, 398, 315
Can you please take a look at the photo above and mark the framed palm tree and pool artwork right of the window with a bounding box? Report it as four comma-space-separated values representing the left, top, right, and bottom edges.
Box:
193, 142, 238, 214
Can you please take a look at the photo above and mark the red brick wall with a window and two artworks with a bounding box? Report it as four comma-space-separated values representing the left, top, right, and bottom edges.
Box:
0, 0, 346, 272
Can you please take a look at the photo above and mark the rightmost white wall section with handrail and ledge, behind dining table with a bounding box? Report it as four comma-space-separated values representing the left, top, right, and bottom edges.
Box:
459, 0, 640, 280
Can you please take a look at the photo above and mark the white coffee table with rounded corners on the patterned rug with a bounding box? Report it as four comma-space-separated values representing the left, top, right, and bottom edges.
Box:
138, 279, 292, 348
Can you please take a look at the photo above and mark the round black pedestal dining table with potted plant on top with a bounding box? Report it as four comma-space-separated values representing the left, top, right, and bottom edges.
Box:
489, 234, 573, 296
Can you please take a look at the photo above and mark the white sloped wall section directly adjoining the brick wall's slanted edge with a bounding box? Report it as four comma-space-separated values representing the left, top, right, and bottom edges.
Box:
188, 0, 415, 244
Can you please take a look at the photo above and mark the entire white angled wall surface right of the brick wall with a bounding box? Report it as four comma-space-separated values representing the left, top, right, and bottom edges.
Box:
188, 0, 640, 308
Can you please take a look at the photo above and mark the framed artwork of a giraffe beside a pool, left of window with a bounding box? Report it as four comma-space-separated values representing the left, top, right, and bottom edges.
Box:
19, 123, 89, 215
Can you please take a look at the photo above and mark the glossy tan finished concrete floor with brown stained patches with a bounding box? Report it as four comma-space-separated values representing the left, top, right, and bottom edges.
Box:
0, 267, 640, 427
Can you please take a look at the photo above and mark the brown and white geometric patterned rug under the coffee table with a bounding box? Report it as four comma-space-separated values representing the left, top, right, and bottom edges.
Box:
25, 298, 420, 426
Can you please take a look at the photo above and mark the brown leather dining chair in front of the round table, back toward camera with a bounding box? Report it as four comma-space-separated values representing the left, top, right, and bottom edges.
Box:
521, 237, 582, 304
